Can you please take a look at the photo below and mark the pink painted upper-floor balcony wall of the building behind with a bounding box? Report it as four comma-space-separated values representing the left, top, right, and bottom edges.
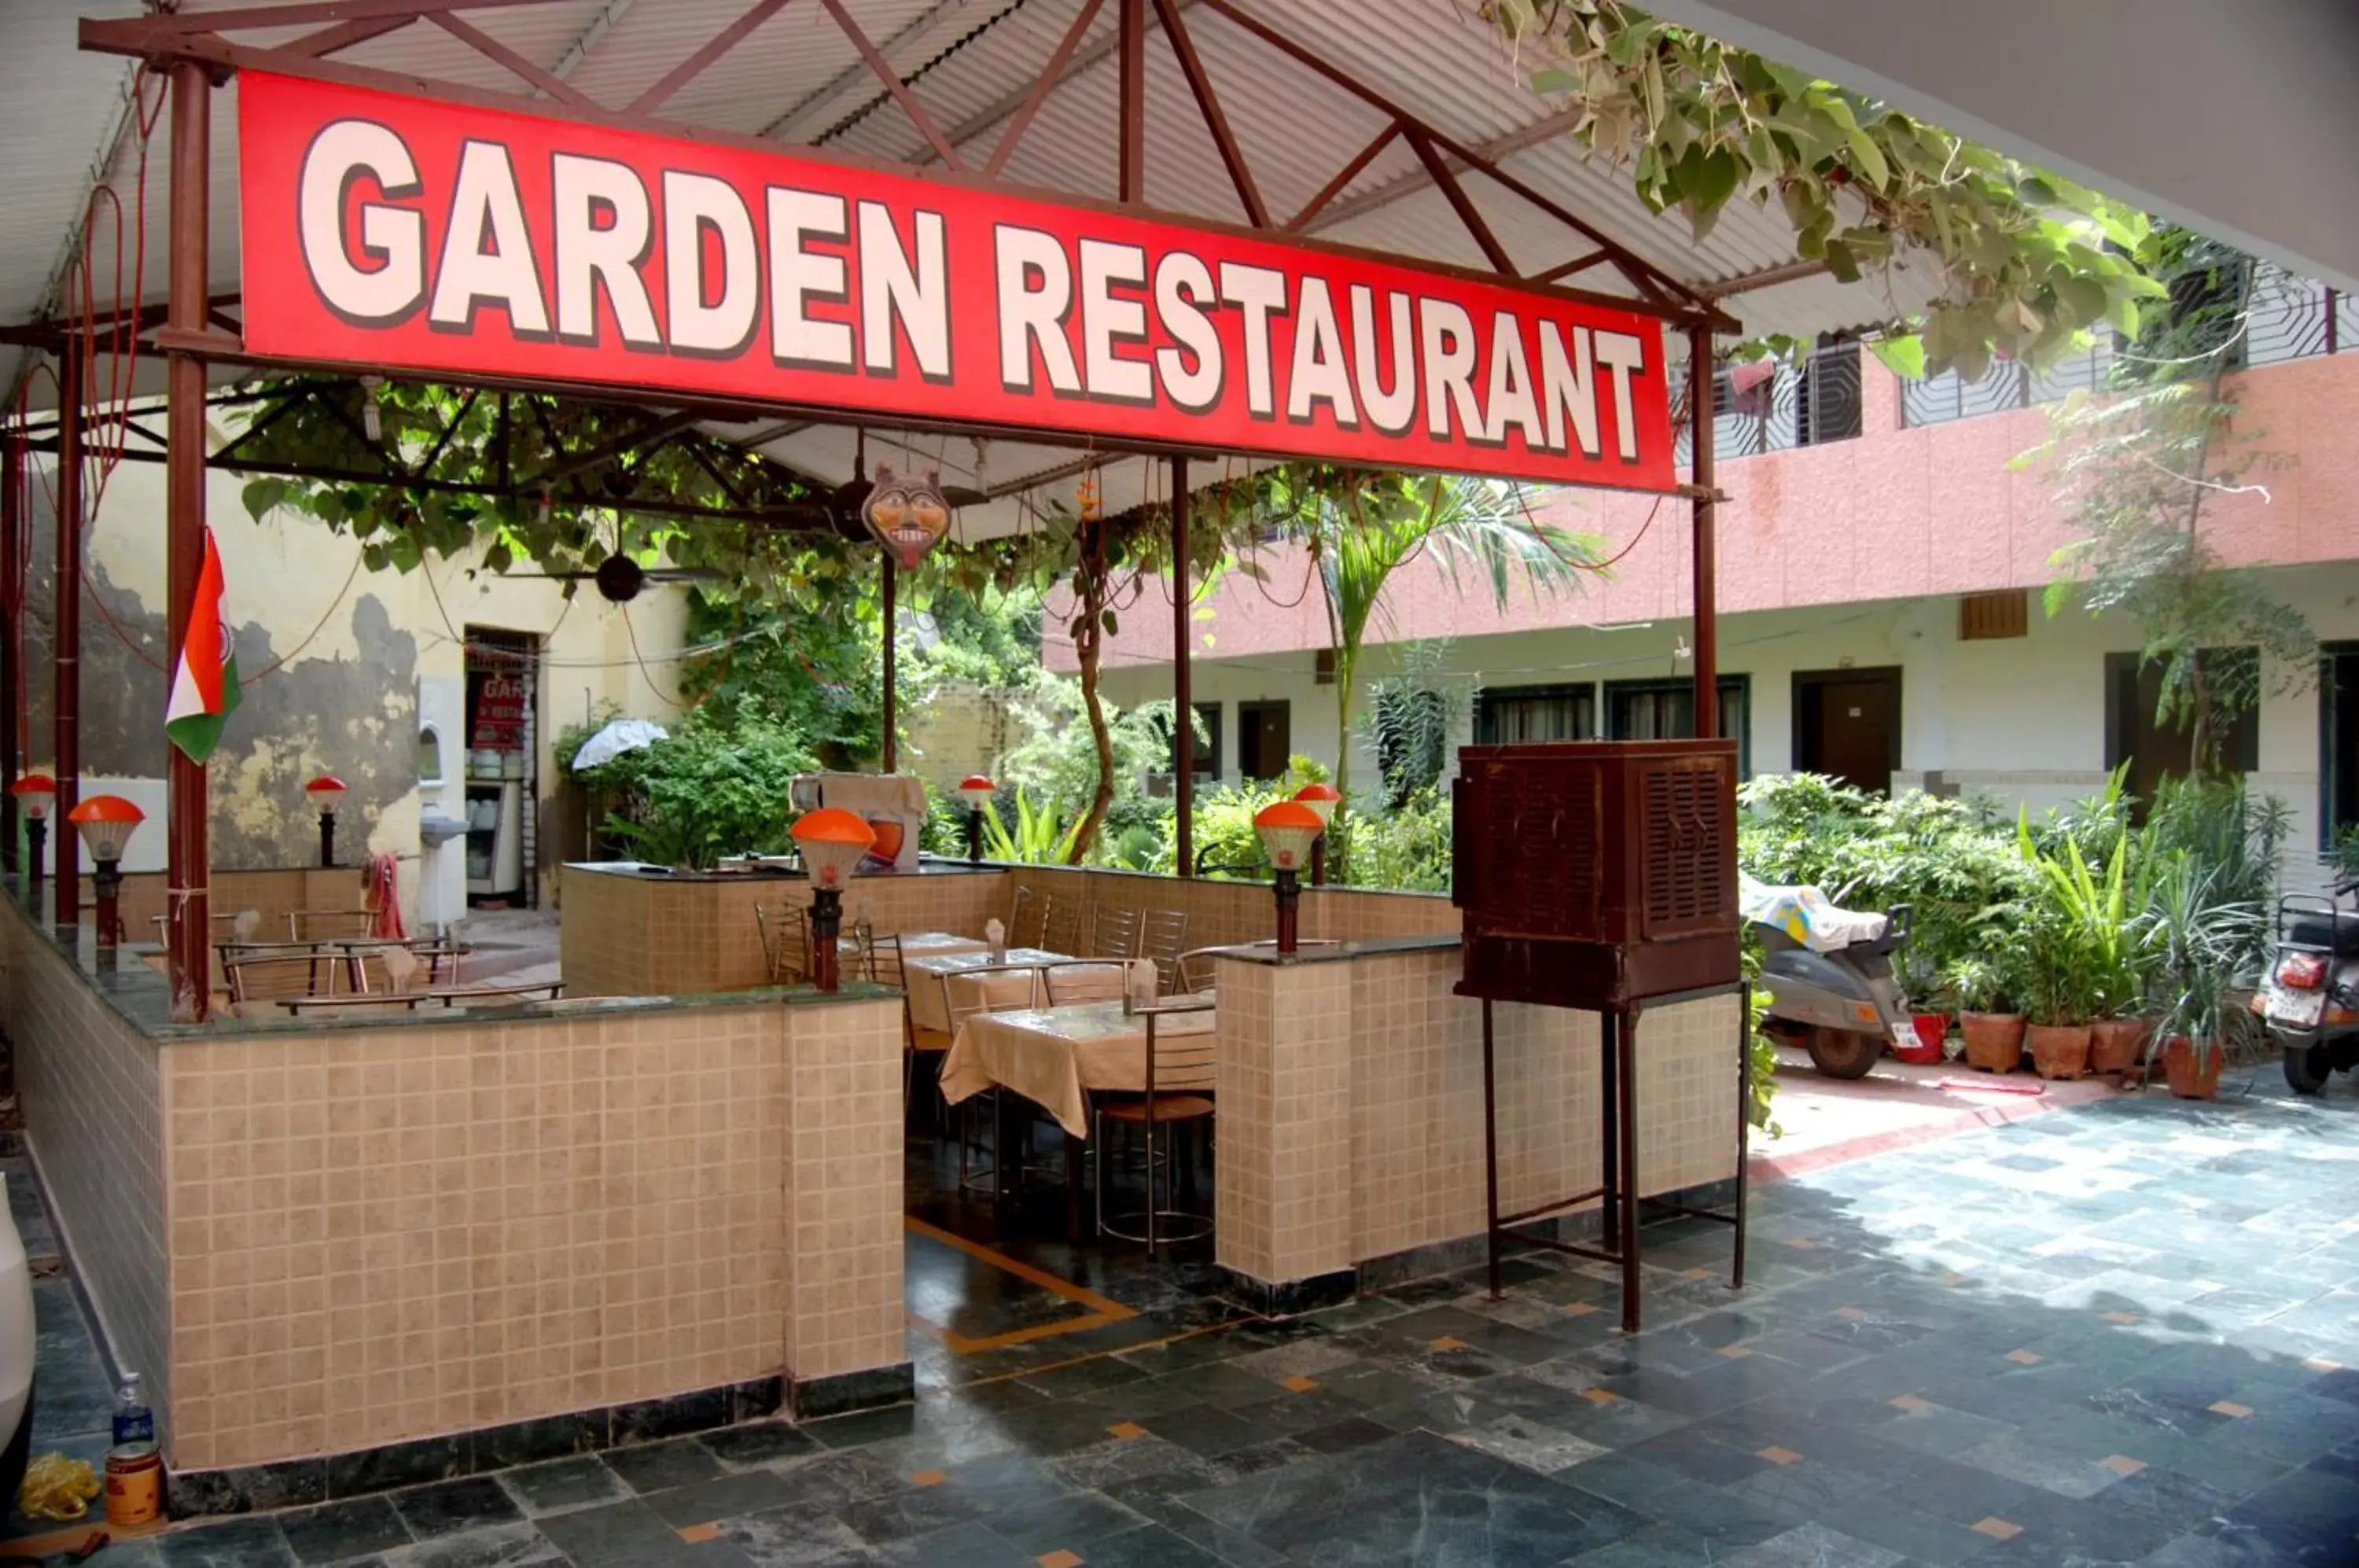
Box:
1043, 354, 2359, 670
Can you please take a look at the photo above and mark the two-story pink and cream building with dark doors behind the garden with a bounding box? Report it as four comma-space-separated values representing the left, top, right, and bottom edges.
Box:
1047, 267, 2359, 848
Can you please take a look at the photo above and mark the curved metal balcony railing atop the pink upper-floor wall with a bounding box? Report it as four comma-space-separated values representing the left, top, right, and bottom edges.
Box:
1901, 262, 2359, 425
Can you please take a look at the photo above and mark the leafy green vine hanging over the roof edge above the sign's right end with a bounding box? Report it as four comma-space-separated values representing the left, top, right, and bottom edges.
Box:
1484, 0, 2161, 380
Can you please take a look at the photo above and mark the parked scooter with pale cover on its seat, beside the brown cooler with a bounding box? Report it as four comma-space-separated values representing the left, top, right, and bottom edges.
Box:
1743, 882, 1916, 1077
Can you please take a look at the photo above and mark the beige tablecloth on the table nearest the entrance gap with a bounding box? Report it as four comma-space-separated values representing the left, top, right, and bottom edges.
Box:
941, 999, 1213, 1139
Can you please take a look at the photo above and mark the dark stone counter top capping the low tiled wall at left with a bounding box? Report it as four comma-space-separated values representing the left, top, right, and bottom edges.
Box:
0, 877, 901, 1042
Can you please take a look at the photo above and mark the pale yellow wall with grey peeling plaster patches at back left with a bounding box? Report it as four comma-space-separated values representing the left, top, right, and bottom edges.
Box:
26, 427, 686, 910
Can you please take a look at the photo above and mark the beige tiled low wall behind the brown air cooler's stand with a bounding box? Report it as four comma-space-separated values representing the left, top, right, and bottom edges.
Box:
1217, 950, 1739, 1283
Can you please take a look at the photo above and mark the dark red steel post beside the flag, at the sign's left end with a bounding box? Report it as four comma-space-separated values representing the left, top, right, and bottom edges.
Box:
165, 61, 213, 1023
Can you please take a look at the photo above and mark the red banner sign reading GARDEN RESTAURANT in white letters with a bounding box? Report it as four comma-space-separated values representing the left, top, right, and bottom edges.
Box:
238, 73, 1675, 491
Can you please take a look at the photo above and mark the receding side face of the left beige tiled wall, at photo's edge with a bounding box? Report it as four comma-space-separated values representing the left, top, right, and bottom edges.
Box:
0, 903, 172, 1452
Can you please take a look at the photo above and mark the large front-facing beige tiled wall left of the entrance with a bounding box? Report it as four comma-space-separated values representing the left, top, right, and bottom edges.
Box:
165, 1002, 906, 1469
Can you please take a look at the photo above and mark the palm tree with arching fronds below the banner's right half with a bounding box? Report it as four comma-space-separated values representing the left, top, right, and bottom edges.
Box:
1269, 469, 1602, 858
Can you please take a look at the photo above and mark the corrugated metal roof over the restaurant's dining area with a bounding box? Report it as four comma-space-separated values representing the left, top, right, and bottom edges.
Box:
0, 0, 1925, 533
